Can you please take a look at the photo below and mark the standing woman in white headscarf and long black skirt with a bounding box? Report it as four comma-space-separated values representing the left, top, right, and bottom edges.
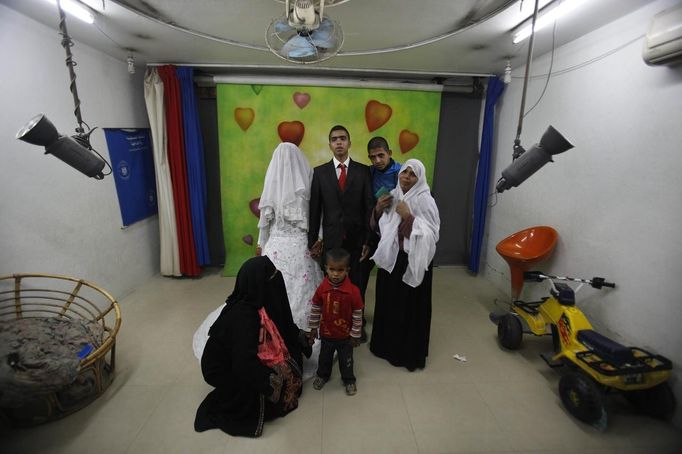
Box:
369, 159, 440, 371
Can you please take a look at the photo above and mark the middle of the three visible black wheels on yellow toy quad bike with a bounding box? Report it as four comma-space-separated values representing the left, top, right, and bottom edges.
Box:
559, 372, 605, 424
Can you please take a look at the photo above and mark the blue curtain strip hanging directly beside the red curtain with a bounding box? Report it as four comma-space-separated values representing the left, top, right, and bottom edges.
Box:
176, 67, 211, 266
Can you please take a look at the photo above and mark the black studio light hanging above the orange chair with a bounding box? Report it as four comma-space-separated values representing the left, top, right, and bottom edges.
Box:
495, 126, 573, 192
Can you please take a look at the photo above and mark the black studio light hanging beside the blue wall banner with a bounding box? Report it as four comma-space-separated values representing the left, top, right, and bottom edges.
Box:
16, 114, 106, 180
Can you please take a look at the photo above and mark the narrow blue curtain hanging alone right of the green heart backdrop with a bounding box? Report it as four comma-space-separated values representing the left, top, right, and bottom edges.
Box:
469, 76, 504, 273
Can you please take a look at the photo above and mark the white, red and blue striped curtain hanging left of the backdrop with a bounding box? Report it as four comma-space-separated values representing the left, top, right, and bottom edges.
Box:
145, 65, 210, 276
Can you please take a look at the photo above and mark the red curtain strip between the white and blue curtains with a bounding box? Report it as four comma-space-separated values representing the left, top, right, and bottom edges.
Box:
158, 65, 201, 276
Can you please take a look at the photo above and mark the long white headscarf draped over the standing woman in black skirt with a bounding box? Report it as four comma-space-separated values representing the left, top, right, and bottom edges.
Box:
372, 159, 440, 287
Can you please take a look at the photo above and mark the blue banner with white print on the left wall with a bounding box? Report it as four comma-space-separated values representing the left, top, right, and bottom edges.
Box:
104, 128, 158, 226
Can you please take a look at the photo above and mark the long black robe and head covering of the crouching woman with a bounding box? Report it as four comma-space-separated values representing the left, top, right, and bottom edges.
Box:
194, 257, 302, 437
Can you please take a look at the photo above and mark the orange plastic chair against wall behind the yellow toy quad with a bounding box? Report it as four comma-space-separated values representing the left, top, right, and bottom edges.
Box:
495, 225, 559, 301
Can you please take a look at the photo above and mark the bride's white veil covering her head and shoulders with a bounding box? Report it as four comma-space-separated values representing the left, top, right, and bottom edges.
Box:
258, 142, 313, 234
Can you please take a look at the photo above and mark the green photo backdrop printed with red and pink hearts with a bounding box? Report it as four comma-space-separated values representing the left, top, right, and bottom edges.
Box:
217, 84, 441, 276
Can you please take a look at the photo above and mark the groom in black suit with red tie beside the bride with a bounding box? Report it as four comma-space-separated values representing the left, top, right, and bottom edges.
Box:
308, 125, 374, 338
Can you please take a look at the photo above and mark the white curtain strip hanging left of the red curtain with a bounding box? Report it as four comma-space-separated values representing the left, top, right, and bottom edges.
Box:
144, 68, 181, 276
